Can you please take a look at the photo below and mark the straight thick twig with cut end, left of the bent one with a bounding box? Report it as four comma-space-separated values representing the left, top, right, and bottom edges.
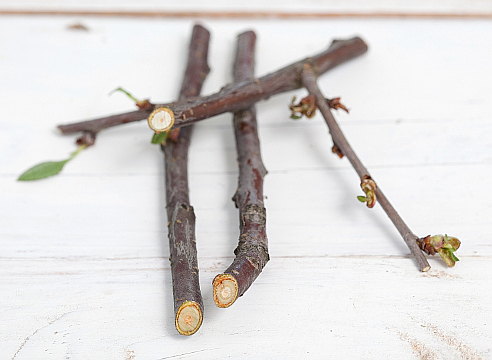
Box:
161, 25, 210, 335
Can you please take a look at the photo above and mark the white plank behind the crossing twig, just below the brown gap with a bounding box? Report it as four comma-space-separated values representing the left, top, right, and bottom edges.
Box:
0, 18, 492, 175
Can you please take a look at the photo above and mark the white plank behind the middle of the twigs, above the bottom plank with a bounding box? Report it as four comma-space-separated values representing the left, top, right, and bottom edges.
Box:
0, 160, 492, 258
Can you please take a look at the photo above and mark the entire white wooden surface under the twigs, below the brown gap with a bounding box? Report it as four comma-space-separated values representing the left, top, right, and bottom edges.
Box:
0, 16, 492, 360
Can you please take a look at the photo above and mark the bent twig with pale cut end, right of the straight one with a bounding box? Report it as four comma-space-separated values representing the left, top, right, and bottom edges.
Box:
213, 31, 269, 307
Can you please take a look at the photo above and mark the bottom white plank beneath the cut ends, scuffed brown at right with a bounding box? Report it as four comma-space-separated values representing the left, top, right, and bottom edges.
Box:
0, 256, 492, 360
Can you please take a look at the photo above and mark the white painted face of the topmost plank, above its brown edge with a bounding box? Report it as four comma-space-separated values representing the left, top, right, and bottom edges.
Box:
0, 0, 492, 14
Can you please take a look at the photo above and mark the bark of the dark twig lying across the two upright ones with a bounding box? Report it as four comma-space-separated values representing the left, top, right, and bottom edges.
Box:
58, 37, 367, 134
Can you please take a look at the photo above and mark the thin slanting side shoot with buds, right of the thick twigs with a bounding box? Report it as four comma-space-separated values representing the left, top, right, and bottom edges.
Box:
302, 66, 430, 271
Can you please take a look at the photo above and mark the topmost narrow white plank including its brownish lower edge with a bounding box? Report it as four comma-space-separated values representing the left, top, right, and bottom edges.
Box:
0, 0, 492, 17
